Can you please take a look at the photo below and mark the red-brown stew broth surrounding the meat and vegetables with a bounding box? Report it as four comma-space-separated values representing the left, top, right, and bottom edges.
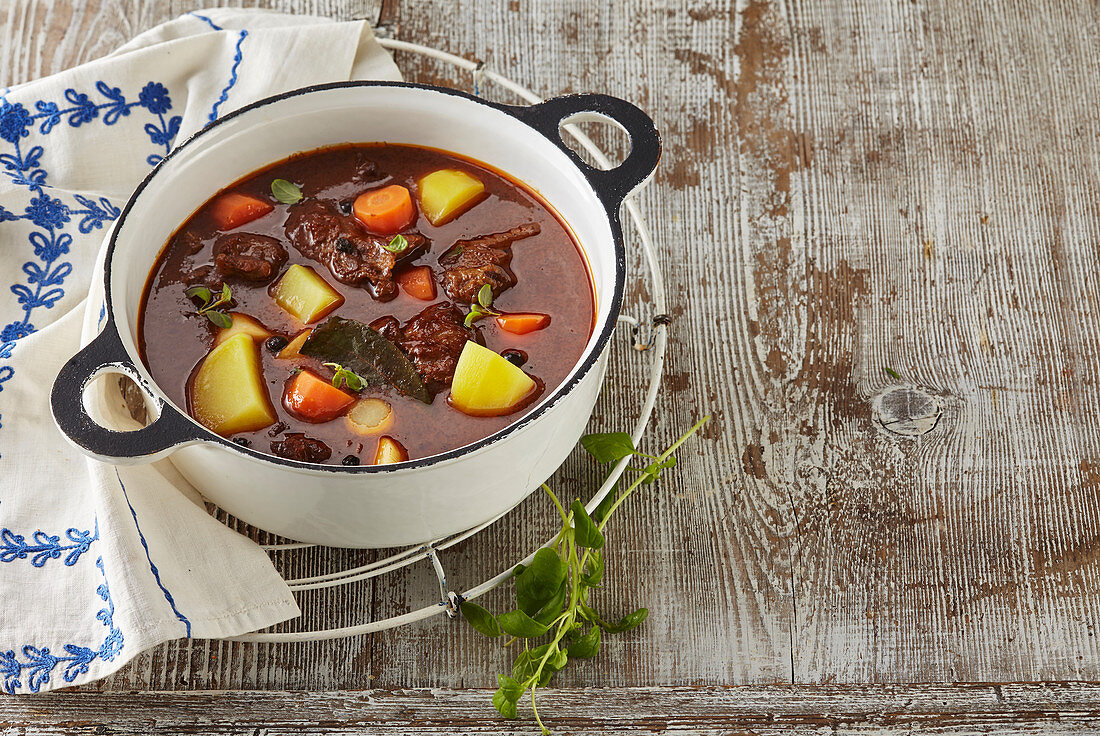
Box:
139, 144, 595, 464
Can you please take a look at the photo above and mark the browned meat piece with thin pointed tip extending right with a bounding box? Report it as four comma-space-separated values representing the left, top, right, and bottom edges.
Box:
439, 222, 541, 304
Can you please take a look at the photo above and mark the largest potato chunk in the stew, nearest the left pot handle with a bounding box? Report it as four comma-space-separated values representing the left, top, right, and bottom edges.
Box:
188, 332, 275, 437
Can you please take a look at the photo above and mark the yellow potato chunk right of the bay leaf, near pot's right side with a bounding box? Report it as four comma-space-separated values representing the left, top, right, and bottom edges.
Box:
450, 341, 537, 417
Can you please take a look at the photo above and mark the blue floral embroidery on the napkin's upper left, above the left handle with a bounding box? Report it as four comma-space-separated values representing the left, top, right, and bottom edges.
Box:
0, 81, 183, 448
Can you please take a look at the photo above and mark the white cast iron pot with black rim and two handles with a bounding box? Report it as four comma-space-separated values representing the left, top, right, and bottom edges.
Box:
51, 83, 660, 547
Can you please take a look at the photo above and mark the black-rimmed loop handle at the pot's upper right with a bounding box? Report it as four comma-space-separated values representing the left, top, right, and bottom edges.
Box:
510, 95, 661, 213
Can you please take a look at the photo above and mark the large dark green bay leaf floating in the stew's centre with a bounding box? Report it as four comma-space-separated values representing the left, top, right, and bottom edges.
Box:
298, 317, 432, 404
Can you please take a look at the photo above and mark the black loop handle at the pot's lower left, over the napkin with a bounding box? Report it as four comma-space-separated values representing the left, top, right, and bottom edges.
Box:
50, 320, 201, 465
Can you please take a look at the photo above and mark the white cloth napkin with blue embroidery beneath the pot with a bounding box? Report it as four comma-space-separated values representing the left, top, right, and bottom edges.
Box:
0, 10, 400, 693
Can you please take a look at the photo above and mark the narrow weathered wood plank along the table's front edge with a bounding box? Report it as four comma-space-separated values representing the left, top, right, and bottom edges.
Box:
0, 683, 1100, 736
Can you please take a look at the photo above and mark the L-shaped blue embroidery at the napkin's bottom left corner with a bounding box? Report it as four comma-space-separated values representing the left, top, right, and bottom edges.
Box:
0, 557, 125, 695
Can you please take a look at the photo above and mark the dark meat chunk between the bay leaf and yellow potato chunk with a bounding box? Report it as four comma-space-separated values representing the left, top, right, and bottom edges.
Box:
371, 301, 483, 393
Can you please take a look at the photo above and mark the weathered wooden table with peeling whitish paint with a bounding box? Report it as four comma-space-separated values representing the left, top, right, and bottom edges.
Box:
0, 0, 1100, 734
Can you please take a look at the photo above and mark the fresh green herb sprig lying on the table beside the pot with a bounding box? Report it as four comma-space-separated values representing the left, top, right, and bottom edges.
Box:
460, 417, 710, 734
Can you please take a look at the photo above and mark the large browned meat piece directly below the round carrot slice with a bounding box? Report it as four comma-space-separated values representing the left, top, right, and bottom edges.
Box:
285, 199, 428, 299
